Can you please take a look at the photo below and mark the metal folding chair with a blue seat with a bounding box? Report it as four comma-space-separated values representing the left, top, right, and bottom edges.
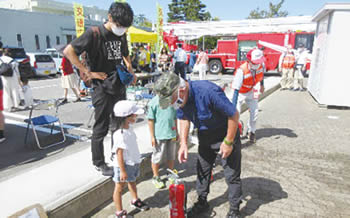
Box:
24, 99, 66, 149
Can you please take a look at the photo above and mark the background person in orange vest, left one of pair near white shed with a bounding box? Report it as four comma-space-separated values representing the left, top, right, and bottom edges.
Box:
278, 45, 295, 91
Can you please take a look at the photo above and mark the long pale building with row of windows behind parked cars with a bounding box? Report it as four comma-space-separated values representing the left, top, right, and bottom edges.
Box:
0, 7, 102, 52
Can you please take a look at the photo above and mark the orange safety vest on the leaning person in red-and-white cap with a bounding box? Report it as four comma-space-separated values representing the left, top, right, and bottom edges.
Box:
239, 62, 264, 93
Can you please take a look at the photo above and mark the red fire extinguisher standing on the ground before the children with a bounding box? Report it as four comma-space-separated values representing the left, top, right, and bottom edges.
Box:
167, 169, 187, 218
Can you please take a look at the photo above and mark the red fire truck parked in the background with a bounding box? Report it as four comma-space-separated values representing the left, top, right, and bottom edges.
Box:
208, 32, 314, 74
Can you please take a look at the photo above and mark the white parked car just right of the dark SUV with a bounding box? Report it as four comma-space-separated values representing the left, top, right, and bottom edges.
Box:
27, 53, 57, 76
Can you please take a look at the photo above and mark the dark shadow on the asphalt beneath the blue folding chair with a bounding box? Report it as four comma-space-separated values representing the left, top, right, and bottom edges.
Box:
0, 124, 76, 175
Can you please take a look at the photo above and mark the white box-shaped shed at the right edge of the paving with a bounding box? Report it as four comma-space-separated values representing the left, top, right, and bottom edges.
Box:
308, 3, 350, 107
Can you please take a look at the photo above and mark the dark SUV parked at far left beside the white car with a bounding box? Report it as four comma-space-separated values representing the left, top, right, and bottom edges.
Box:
4, 46, 33, 77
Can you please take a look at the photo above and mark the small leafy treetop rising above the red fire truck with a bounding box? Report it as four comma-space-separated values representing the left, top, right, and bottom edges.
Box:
248, 0, 288, 19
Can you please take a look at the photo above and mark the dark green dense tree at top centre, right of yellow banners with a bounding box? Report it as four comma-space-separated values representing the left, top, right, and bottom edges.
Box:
168, 0, 211, 22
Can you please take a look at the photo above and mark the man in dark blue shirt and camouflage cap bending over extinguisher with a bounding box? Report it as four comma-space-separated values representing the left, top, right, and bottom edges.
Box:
154, 73, 242, 218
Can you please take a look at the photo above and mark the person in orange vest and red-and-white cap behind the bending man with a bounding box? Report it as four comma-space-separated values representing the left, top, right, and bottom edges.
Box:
232, 48, 265, 143
